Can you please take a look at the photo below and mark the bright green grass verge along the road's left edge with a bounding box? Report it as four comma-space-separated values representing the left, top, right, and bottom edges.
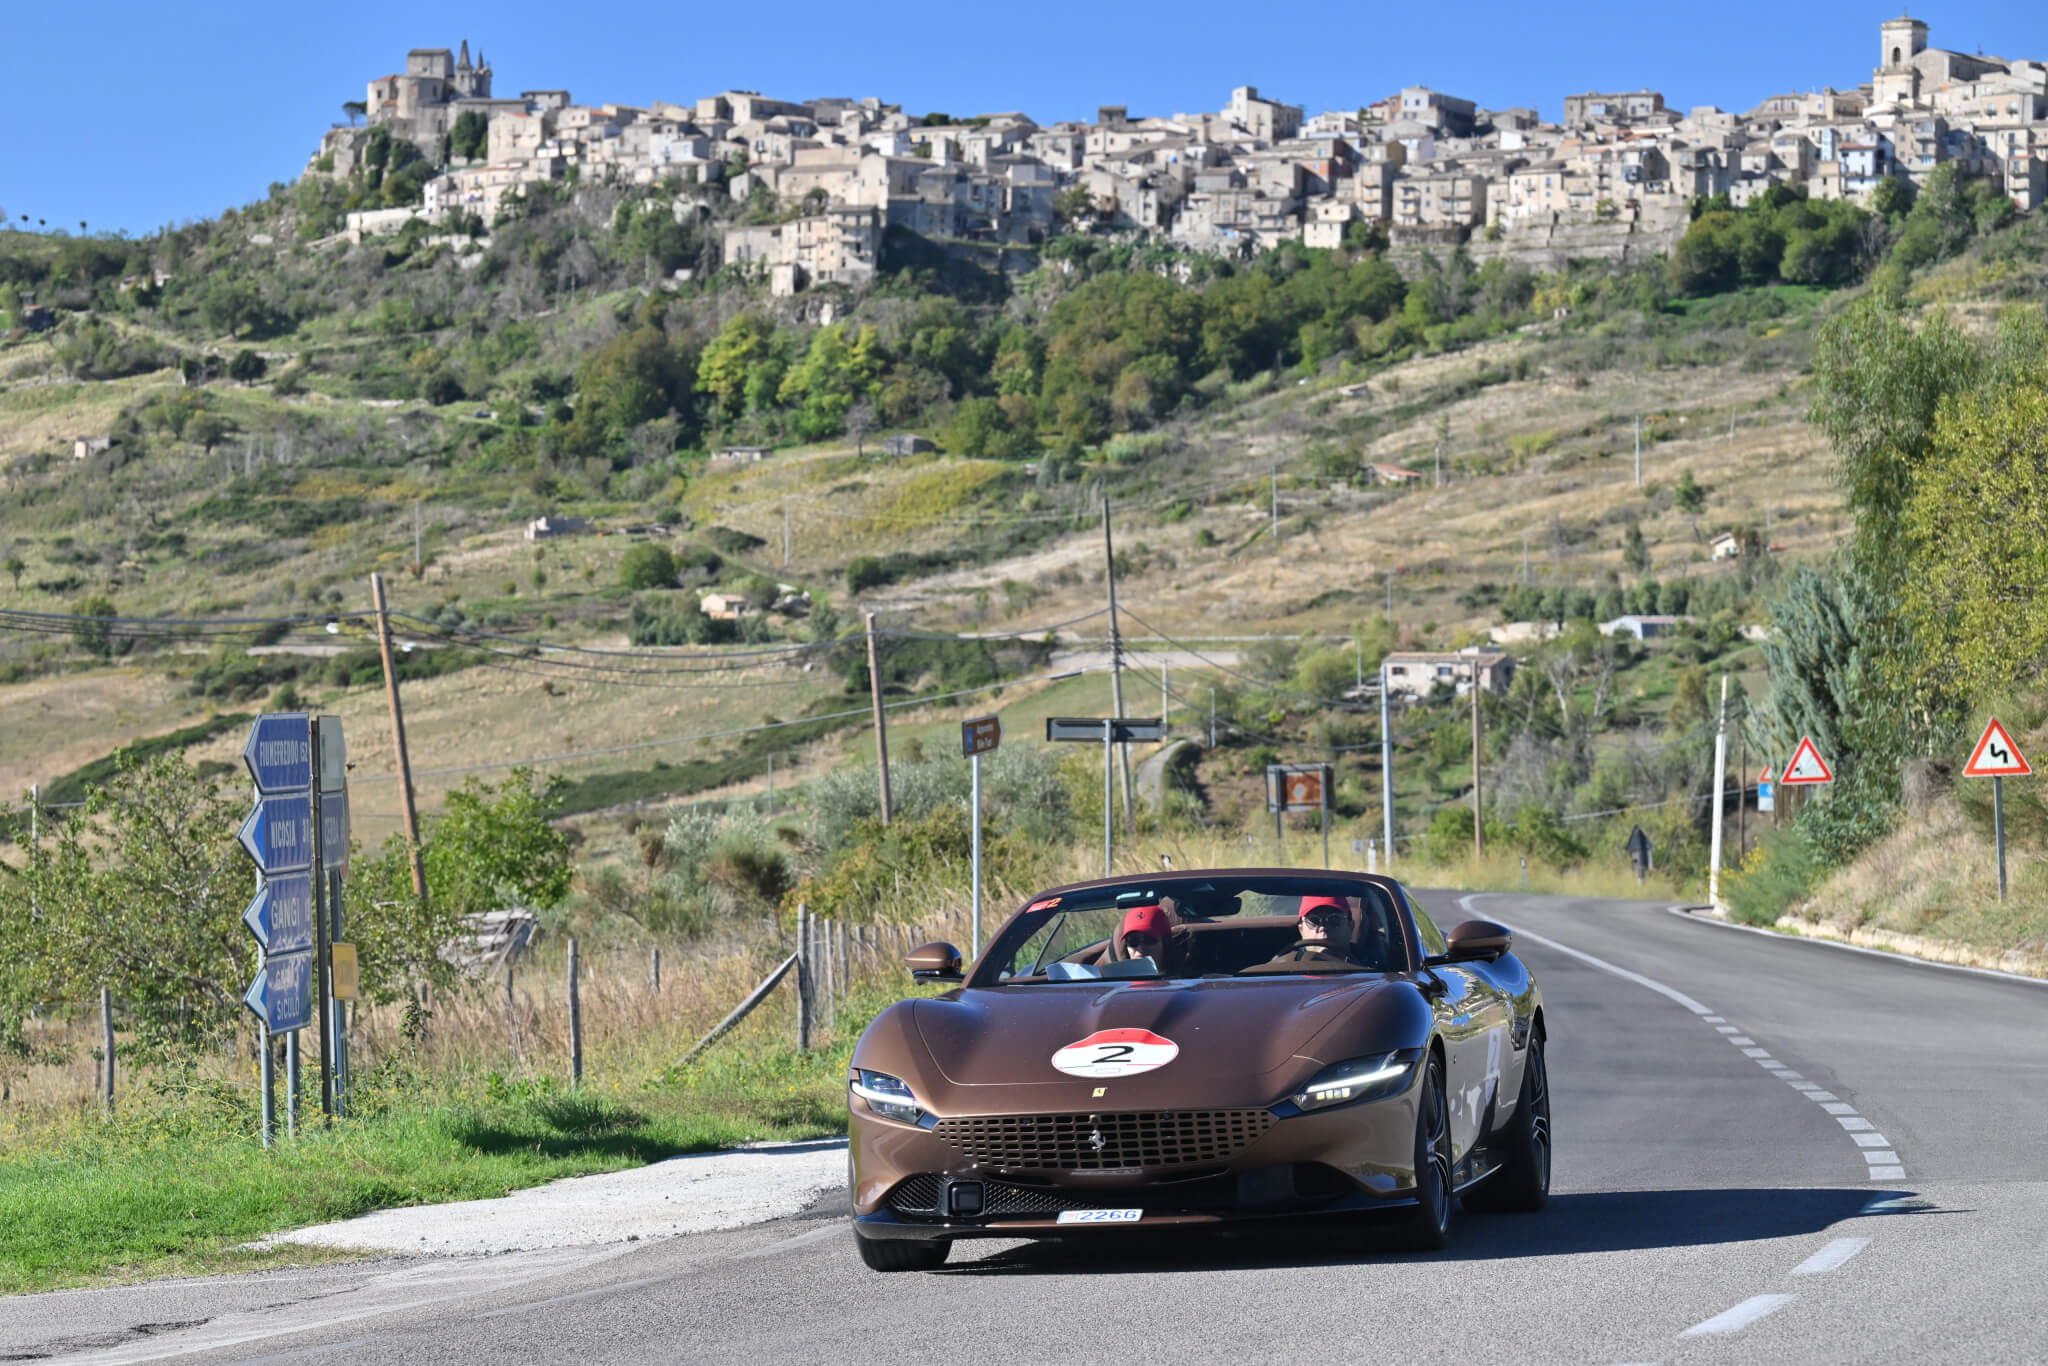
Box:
0, 991, 895, 1294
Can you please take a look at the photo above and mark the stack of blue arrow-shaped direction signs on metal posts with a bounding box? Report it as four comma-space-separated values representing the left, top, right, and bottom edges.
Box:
238, 711, 315, 1147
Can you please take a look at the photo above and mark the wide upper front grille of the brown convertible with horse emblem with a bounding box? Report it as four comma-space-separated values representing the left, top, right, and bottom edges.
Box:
934, 1110, 1274, 1171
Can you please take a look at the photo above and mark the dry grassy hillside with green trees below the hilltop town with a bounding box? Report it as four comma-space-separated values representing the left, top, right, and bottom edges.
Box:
0, 179, 2042, 950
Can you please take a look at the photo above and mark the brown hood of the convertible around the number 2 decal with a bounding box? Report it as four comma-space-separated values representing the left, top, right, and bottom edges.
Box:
911, 975, 1405, 1108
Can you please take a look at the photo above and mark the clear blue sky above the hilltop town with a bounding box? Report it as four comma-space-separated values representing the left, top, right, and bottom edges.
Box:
0, 0, 2048, 233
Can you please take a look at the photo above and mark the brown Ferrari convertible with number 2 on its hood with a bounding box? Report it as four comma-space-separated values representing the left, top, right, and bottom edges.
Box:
848, 868, 1550, 1272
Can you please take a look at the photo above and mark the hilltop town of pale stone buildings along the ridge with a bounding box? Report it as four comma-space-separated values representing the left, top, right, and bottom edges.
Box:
309, 18, 2048, 293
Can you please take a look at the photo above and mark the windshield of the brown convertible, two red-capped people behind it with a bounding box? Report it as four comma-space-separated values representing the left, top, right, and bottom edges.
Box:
973, 874, 1409, 987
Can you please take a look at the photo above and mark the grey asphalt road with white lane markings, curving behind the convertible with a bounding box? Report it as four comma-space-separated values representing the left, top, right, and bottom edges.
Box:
0, 893, 2048, 1366
